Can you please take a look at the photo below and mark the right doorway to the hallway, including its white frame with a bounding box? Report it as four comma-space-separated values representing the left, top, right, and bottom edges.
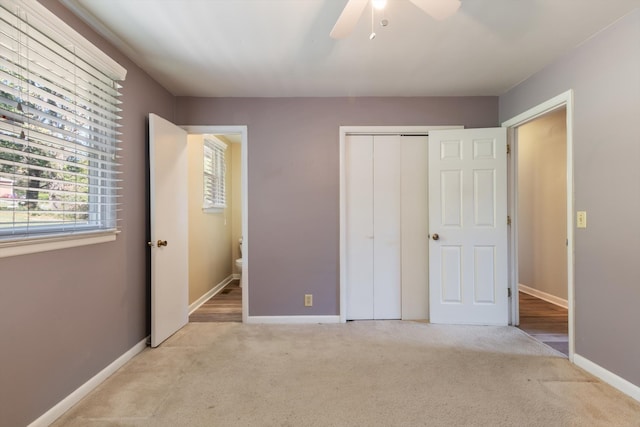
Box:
503, 91, 574, 360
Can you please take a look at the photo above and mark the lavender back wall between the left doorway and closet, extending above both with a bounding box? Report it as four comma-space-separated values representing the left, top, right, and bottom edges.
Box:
176, 97, 498, 316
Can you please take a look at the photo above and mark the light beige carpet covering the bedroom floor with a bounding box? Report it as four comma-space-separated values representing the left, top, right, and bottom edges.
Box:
54, 321, 640, 427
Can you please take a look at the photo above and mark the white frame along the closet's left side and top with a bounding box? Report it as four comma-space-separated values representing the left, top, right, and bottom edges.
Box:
340, 126, 464, 323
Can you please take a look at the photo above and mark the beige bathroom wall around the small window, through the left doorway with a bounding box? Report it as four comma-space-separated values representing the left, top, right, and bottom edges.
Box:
188, 135, 233, 304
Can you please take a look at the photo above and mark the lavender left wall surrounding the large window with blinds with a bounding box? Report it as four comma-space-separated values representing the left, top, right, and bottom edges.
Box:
0, 0, 174, 427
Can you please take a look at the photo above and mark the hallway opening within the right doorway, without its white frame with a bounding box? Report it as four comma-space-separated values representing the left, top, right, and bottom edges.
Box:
512, 108, 569, 356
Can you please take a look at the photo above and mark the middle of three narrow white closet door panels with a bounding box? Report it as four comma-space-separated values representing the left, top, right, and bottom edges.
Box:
373, 135, 402, 319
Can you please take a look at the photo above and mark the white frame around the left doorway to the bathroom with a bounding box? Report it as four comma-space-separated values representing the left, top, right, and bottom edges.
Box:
180, 125, 249, 323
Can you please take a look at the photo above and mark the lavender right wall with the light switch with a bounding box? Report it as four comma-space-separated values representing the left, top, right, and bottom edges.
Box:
500, 9, 640, 386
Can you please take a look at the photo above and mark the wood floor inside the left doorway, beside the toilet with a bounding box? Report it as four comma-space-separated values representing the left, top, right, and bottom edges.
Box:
189, 280, 242, 322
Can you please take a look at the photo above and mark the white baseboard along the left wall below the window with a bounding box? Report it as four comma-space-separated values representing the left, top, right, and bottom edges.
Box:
29, 337, 149, 427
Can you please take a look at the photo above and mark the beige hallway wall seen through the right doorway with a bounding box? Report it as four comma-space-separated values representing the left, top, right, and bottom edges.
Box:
517, 109, 567, 299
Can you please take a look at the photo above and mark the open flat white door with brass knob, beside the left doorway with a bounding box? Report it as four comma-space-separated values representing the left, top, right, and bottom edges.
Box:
149, 114, 189, 347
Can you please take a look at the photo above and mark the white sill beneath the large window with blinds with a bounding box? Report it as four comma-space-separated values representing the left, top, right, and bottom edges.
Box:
0, 231, 119, 258
